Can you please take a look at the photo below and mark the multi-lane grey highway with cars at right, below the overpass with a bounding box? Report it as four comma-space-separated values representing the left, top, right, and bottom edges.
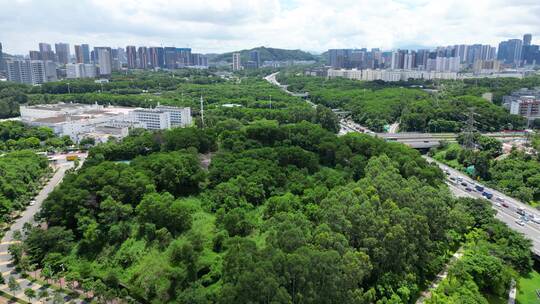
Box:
424, 156, 540, 256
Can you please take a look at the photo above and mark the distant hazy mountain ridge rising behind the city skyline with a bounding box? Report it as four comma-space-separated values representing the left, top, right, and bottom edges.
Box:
209, 46, 319, 62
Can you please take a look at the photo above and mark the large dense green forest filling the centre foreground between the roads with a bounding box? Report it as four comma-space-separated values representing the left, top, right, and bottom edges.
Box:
13, 120, 527, 303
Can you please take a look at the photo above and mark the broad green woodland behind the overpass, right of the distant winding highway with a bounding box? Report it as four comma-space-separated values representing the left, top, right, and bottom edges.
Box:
280, 75, 528, 132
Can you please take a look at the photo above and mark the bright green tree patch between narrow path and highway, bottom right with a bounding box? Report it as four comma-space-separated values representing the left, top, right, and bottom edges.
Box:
426, 199, 532, 304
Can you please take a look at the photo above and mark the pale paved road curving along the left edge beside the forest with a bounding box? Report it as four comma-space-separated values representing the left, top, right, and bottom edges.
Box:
0, 158, 84, 303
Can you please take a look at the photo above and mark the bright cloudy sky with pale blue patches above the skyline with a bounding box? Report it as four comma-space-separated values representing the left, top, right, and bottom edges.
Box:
0, 0, 540, 54
